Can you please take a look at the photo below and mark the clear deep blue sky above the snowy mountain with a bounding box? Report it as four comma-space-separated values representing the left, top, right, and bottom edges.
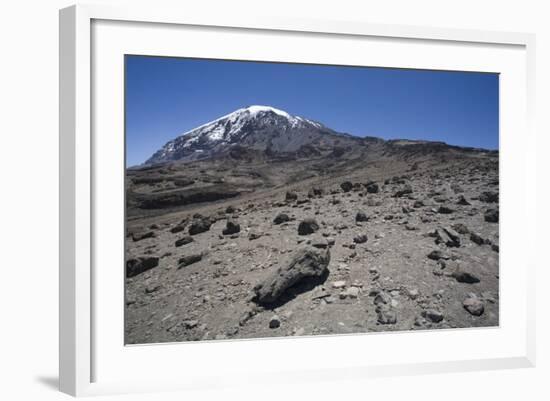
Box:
126, 56, 499, 166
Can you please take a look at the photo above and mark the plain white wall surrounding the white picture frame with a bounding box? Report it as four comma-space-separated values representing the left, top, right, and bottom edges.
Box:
0, 0, 550, 401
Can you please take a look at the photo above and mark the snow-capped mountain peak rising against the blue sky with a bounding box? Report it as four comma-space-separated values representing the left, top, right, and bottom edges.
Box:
145, 106, 356, 164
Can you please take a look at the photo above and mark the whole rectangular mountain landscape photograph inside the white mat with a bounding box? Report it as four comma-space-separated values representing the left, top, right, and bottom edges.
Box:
124, 55, 499, 344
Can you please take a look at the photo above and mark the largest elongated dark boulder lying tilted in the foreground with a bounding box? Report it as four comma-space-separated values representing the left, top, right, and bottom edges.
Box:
254, 247, 330, 304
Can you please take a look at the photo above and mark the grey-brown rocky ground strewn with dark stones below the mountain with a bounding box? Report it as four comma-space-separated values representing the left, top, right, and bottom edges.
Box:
125, 153, 499, 344
